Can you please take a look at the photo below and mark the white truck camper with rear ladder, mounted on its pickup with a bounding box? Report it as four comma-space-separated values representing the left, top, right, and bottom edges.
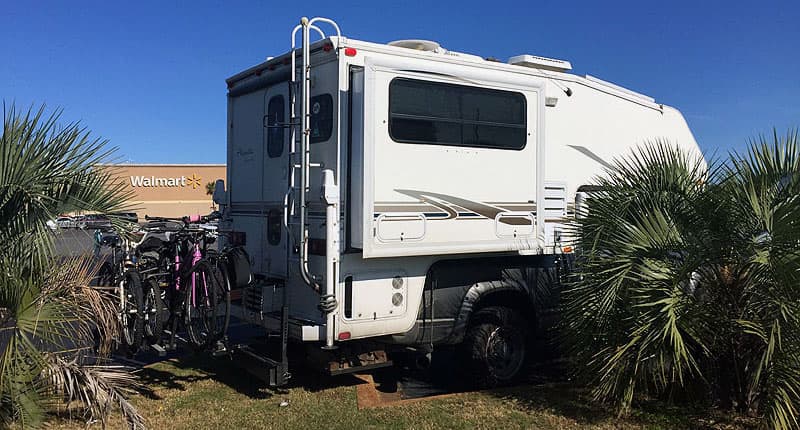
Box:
215, 18, 698, 385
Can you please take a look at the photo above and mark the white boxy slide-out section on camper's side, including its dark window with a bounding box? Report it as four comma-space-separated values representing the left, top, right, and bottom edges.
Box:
361, 57, 544, 258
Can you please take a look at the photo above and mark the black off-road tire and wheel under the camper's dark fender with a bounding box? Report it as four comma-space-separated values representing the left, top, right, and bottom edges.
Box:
463, 306, 528, 388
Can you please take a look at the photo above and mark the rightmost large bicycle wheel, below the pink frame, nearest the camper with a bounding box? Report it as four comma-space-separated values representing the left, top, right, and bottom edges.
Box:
184, 260, 230, 348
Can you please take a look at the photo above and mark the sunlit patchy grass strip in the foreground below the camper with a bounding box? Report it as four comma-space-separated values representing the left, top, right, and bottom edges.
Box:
45, 357, 756, 430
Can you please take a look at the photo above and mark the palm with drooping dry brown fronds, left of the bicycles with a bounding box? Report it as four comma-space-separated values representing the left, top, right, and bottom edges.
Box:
0, 106, 142, 426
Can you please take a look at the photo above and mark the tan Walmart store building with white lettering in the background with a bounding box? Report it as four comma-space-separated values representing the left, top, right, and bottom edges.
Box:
112, 164, 225, 222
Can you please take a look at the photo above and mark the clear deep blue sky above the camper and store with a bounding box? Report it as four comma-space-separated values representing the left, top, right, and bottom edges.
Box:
0, 0, 800, 163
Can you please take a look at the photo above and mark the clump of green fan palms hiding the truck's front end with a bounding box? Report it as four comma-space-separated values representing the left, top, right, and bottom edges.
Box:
563, 132, 800, 428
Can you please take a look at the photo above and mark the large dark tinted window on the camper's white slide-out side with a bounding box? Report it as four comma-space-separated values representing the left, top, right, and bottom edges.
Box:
389, 78, 527, 150
